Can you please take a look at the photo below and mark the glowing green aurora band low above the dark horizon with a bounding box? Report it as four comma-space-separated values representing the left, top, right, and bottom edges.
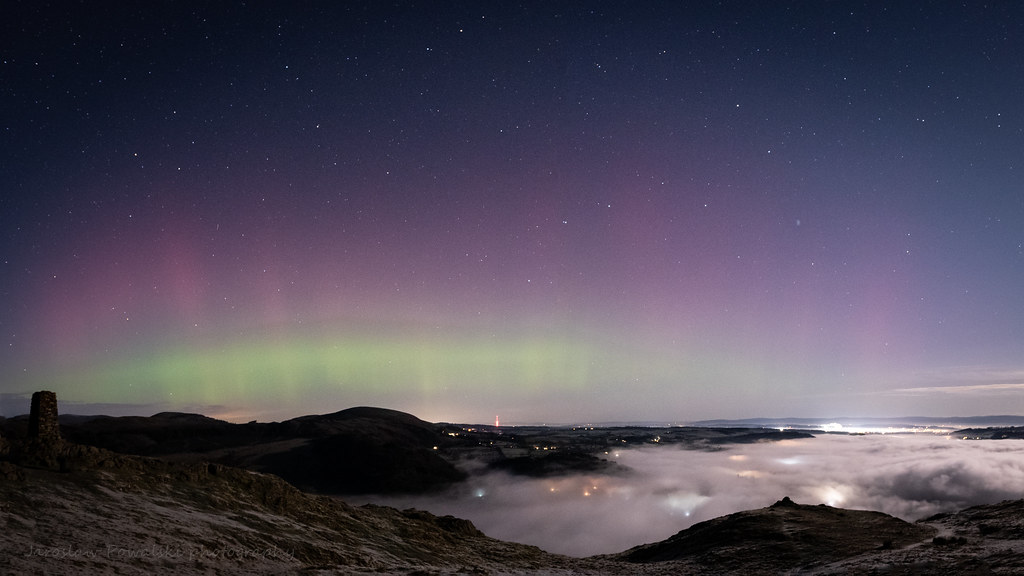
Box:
14, 331, 798, 421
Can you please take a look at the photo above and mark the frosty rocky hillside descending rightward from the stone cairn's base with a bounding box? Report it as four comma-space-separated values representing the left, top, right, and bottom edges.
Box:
0, 446, 603, 575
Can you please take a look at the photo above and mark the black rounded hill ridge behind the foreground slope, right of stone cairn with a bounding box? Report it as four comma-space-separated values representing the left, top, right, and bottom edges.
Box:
32, 407, 465, 494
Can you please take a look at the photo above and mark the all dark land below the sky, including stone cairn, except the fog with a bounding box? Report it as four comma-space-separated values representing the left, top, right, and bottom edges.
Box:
6, 393, 1024, 575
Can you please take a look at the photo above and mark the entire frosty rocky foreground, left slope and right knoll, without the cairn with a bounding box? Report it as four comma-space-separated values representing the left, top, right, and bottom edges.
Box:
6, 443, 1024, 575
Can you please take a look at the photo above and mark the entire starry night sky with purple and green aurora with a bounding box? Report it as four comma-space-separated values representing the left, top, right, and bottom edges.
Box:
0, 1, 1024, 423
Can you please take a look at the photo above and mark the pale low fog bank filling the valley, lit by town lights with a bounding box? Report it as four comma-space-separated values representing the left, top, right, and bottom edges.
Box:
351, 435, 1024, 557
